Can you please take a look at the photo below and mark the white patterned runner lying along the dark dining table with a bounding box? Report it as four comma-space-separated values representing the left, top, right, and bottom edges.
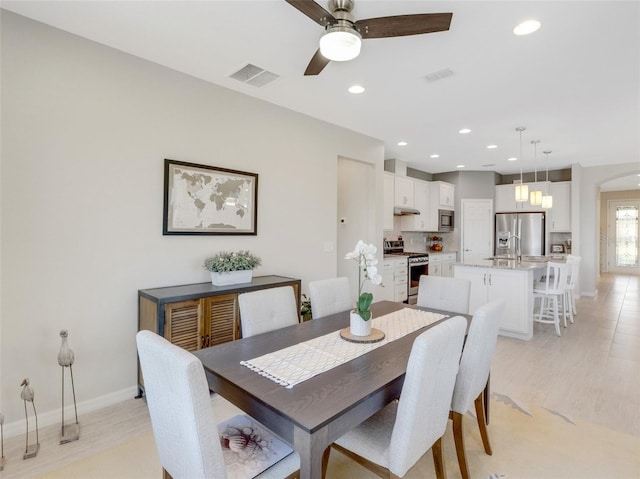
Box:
240, 308, 446, 389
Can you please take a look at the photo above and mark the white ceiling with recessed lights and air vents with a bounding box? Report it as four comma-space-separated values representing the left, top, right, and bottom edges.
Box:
2, 0, 640, 183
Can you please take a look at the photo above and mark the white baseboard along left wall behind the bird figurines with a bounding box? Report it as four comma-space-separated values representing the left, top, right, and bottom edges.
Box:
4, 386, 138, 438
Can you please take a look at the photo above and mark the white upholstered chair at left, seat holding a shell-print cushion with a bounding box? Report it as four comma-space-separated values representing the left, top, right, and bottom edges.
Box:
136, 330, 300, 479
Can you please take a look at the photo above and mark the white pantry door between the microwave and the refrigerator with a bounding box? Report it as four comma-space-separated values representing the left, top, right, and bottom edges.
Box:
460, 200, 493, 262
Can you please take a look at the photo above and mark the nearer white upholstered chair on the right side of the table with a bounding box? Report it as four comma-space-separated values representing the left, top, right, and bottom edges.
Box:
325, 316, 467, 479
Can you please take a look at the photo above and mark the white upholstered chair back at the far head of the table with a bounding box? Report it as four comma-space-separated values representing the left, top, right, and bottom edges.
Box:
417, 275, 471, 314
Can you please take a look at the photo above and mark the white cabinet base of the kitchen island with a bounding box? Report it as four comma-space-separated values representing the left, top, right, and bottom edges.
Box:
454, 264, 533, 341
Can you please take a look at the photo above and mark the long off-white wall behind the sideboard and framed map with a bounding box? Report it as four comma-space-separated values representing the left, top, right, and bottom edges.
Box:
0, 11, 384, 432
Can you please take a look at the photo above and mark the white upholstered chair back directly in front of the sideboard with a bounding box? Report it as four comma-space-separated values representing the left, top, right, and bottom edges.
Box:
238, 286, 300, 338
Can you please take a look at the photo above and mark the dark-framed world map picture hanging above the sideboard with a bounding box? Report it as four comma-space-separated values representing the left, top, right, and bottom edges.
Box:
162, 160, 258, 235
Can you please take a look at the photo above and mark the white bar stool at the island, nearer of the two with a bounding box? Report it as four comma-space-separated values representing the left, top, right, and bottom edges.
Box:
533, 261, 569, 336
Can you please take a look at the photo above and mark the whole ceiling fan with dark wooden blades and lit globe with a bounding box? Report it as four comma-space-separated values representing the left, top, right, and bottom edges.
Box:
285, 0, 453, 75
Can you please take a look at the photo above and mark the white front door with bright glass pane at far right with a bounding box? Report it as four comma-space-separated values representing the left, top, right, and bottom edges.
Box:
607, 200, 640, 275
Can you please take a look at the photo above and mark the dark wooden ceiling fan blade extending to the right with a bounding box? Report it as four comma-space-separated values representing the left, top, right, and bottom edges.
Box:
355, 13, 453, 38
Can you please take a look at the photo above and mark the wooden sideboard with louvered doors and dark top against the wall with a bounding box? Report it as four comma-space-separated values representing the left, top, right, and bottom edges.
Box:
138, 276, 300, 394
